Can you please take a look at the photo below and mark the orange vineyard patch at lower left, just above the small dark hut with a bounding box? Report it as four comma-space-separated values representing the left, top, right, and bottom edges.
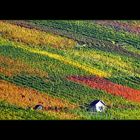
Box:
0, 80, 76, 109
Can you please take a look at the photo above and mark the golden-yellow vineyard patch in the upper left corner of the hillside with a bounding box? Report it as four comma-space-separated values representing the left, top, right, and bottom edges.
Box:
0, 21, 76, 48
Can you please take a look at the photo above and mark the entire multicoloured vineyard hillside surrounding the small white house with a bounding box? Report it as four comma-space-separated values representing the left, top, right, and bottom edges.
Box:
0, 20, 140, 120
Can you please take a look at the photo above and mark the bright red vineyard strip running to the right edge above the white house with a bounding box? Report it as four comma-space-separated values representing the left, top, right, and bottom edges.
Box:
68, 76, 140, 102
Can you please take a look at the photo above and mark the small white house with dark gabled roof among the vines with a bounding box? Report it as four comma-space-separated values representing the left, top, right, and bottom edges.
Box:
89, 100, 106, 112
